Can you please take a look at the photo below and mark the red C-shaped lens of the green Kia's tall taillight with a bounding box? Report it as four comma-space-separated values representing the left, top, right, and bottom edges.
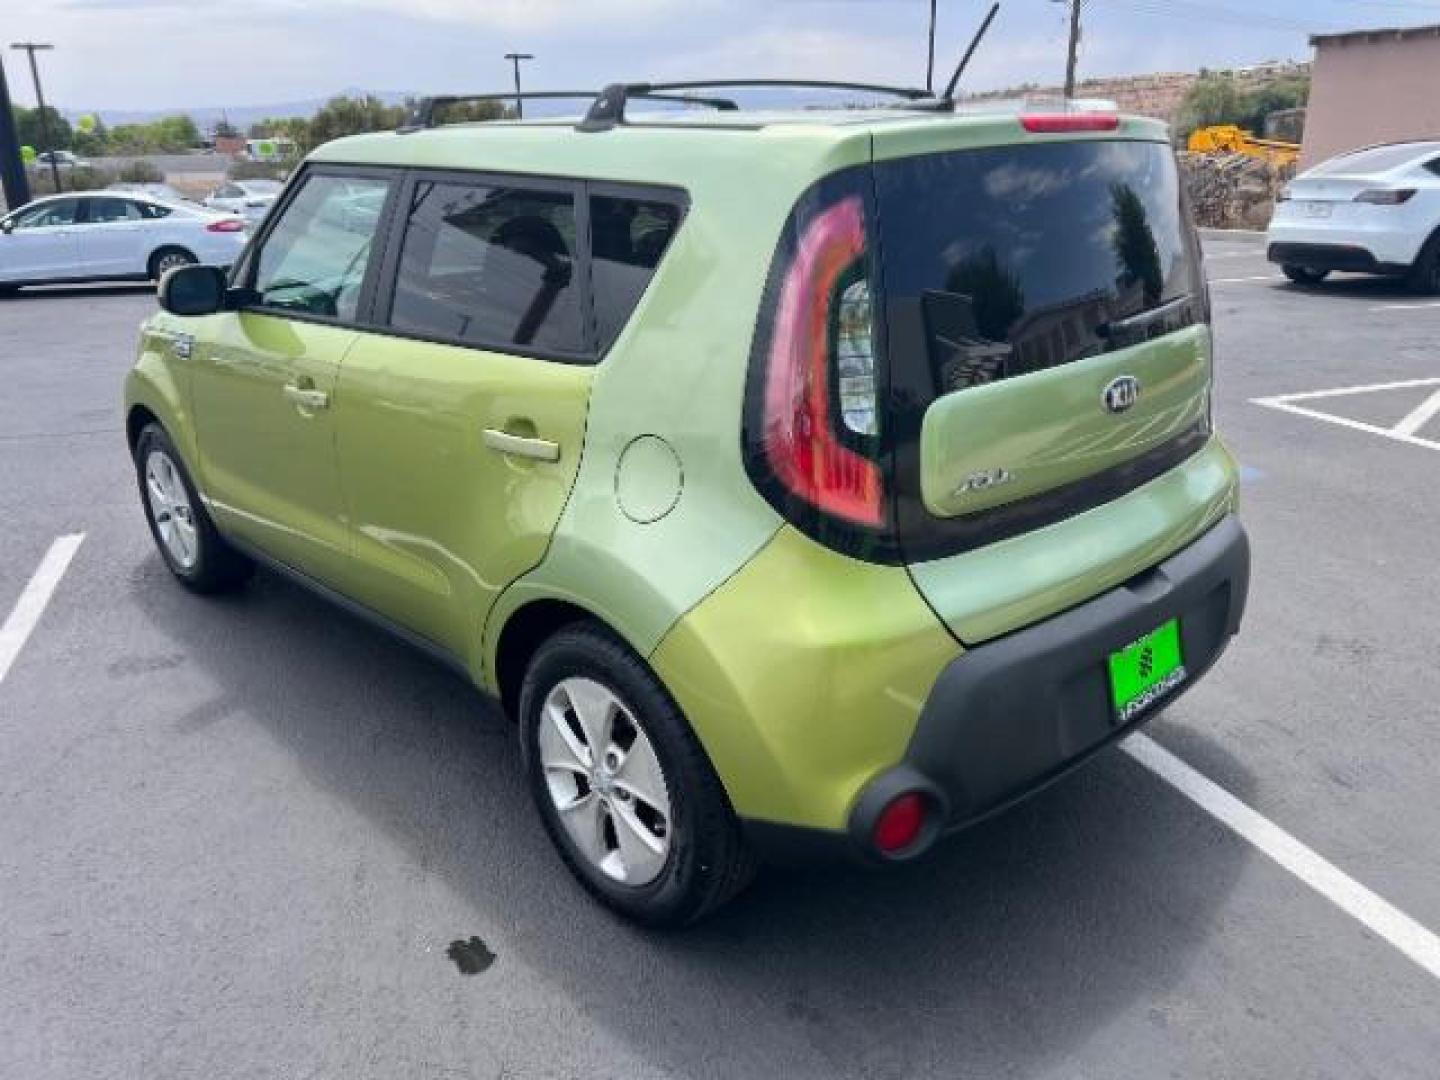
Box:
762, 196, 886, 527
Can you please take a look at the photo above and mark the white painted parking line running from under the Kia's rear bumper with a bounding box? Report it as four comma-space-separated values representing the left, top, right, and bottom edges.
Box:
1120, 734, 1440, 979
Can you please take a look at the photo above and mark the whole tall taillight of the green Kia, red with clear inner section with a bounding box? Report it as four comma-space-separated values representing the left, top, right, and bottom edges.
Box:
747, 194, 886, 528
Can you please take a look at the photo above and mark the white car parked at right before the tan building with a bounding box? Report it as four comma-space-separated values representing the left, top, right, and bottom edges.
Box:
1267, 141, 1440, 295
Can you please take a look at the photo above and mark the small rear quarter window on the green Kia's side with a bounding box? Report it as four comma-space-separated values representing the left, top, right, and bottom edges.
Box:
590, 196, 683, 353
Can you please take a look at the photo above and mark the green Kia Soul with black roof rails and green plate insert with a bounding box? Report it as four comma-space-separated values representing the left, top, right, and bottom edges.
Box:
125, 84, 1248, 924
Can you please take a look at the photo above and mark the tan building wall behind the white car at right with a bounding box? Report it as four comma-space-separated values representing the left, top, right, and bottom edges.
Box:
1300, 26, 1440, 168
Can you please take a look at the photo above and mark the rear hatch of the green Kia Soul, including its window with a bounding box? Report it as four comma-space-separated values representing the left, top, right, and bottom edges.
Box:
874, 114, 1233, 644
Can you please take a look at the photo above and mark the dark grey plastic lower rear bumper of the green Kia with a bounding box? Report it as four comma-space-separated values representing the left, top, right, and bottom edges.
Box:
750, 516, 1250, 860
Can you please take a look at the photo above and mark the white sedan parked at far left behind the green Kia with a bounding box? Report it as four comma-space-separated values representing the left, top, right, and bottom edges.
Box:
0, 193, 246, 292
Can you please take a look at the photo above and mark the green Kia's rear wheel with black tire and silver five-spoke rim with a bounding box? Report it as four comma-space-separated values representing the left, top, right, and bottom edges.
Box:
520, 622, 756, 927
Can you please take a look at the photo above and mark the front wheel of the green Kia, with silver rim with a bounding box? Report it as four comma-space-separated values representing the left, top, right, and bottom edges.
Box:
135, 423, 255, 593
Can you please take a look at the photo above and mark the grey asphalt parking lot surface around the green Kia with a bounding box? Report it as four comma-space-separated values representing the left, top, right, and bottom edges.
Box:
8, 239, 1440, 1080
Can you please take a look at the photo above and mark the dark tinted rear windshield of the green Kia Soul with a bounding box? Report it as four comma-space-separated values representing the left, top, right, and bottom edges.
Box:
876, 141, 1202, 396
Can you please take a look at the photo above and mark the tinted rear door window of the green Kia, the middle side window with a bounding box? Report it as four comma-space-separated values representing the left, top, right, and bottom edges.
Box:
389, 179, 585, 356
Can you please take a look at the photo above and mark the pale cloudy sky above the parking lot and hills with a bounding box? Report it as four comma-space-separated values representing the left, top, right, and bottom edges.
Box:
8, 0, 1440, 111
